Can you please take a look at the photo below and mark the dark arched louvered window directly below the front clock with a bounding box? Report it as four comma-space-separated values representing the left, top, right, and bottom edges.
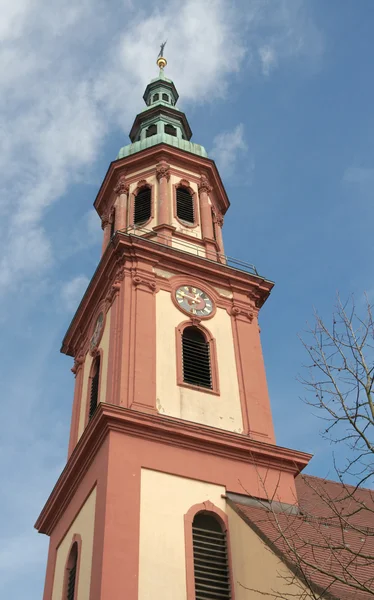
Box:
182, 326, 213, 389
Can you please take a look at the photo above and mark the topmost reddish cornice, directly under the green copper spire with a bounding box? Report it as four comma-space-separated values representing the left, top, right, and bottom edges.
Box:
94, 144, 230, 217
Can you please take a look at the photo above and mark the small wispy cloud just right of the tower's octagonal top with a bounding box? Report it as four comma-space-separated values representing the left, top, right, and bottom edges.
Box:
210, 123, 253, 176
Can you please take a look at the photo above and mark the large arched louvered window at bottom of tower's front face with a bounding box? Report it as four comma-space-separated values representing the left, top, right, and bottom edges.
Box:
192, 513, 231, 600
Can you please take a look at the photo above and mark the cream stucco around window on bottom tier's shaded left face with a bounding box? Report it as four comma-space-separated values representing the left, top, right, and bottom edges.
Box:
52, 488, 96, 600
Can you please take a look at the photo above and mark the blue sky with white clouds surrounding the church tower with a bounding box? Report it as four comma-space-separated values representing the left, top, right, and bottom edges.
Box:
0, 0, 374, 600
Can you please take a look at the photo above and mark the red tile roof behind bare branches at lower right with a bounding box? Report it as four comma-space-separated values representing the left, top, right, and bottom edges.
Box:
230, 475, 374, 600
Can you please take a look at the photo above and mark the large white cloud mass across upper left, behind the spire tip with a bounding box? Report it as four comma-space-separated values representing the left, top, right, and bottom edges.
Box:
0, 0, 318, 298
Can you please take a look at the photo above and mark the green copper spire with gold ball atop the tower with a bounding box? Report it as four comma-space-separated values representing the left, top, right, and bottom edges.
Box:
117, 51, 207, 158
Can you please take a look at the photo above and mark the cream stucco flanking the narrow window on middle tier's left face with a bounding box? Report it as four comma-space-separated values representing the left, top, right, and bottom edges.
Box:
78, 308, 112, 439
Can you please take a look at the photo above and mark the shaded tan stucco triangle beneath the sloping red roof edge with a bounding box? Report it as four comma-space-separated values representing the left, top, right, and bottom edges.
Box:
226, 506, 305, 600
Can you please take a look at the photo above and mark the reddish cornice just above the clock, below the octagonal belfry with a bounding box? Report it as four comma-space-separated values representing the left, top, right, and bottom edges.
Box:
61, 232, 274, 356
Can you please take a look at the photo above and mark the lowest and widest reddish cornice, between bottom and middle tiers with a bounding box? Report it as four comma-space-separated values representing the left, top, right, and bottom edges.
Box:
35, 403, 311, 535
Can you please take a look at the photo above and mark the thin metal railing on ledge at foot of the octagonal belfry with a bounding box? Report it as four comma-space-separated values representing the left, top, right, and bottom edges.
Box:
117, 225, 258, 275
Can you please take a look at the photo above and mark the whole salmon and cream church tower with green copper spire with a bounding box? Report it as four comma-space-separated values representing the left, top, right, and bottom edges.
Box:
36, 56, 310, 600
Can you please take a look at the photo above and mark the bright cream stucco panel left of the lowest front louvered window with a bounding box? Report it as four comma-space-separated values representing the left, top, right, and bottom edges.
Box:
138, 469, 225, 600
